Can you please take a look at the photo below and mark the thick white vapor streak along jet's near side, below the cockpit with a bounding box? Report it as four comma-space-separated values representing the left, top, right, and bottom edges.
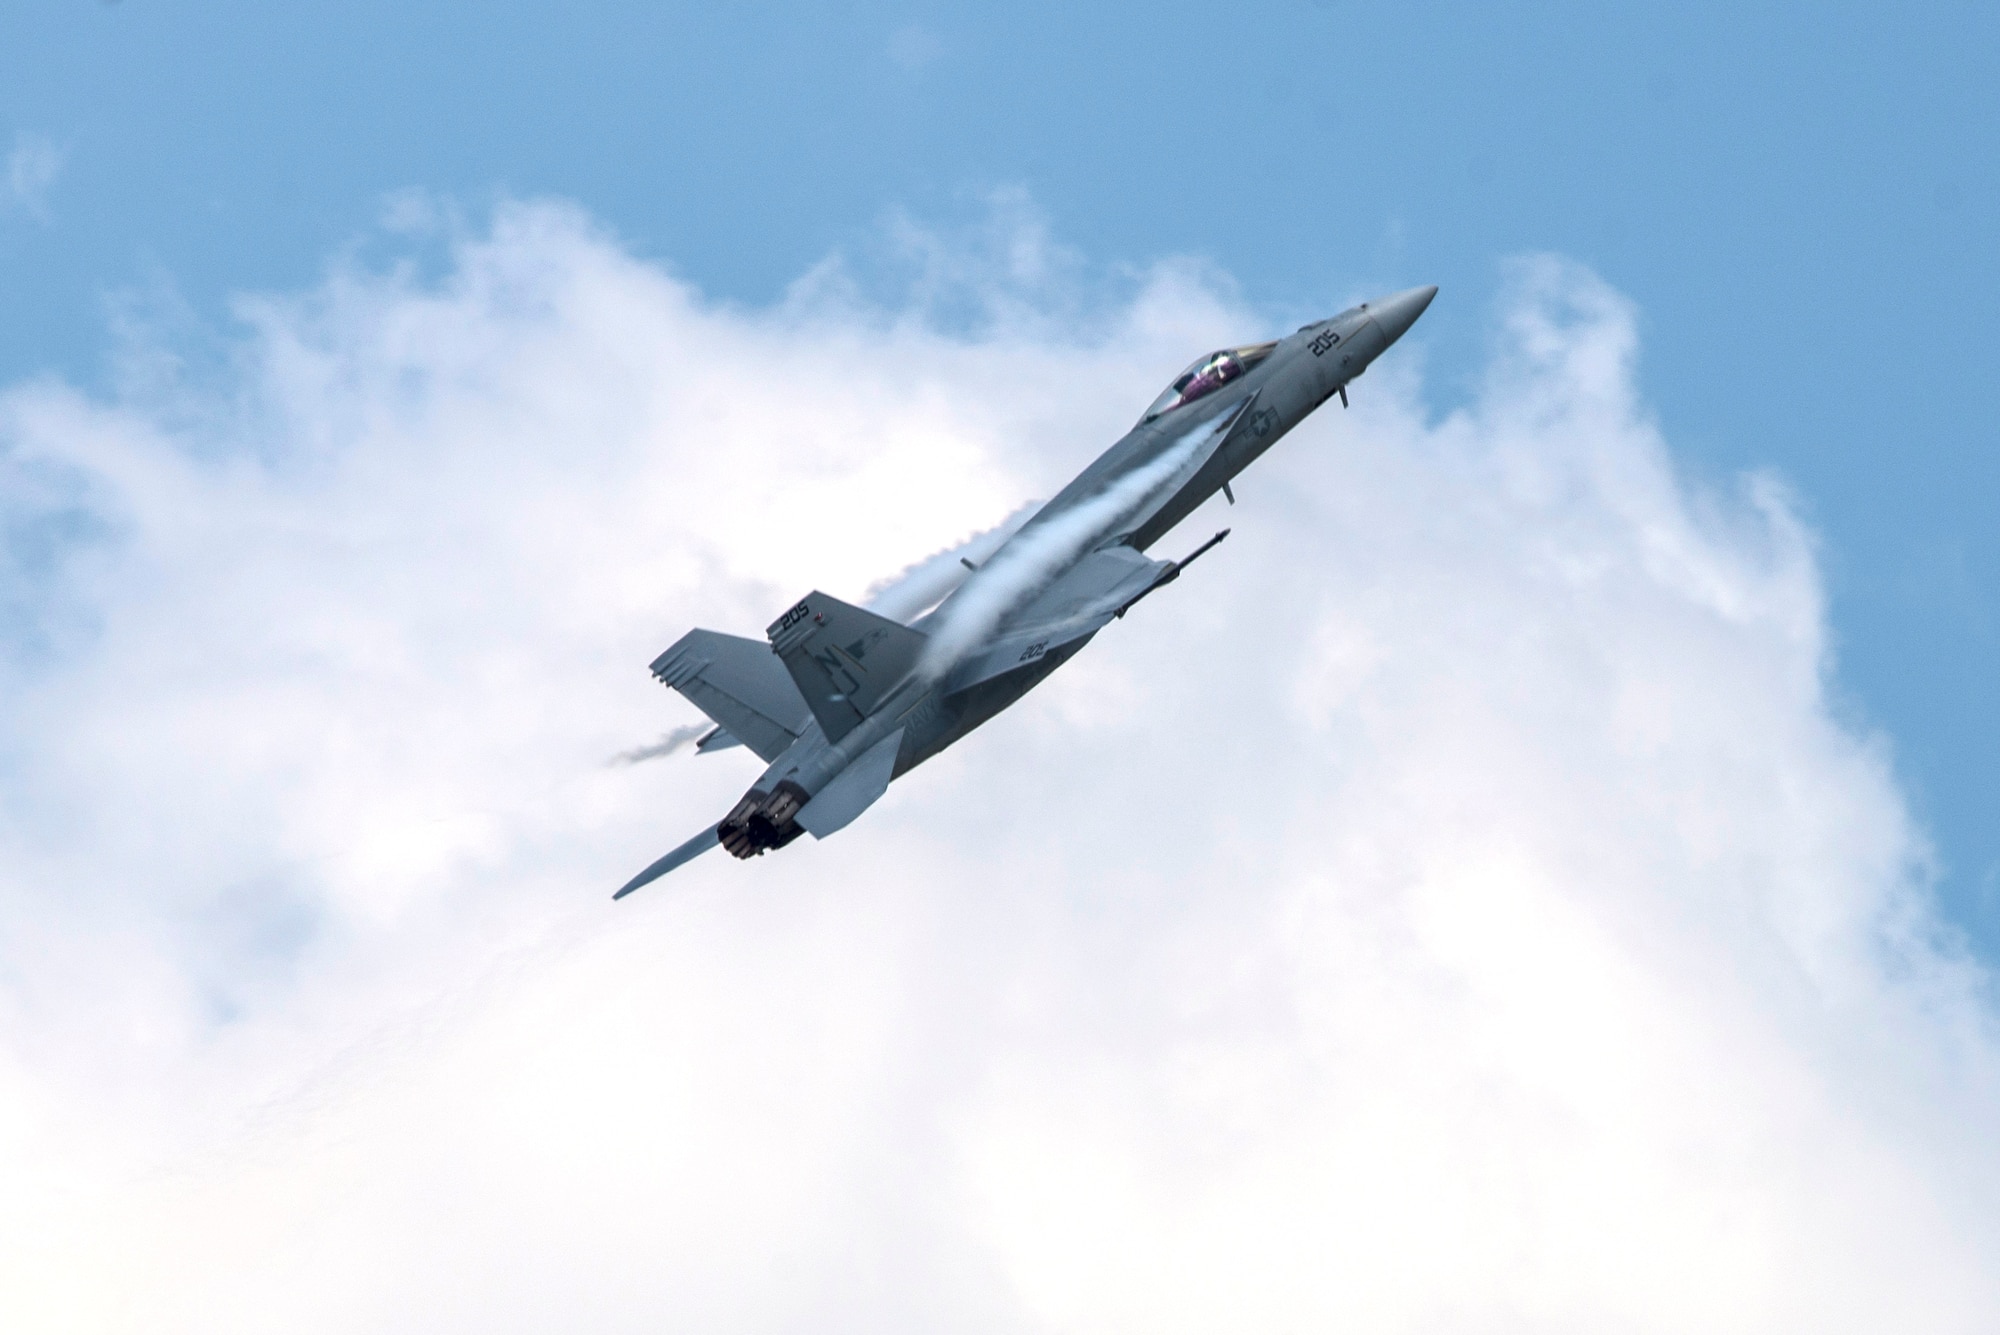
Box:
920, 414, 1234, 677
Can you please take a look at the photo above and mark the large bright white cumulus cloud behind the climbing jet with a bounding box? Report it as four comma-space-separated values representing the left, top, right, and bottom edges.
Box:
0, 204, 2000, 1331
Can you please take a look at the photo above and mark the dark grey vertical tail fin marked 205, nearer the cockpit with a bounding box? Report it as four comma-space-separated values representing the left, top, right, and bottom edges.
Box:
764, 592, 924, 741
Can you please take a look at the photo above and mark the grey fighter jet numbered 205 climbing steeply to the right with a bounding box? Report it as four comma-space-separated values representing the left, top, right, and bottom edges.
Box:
612, 288, 1438, 899
